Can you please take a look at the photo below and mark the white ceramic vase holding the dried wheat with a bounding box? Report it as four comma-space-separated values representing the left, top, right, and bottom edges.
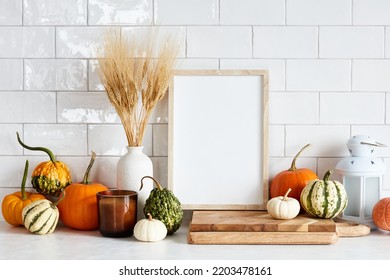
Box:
116, 146, 153, 220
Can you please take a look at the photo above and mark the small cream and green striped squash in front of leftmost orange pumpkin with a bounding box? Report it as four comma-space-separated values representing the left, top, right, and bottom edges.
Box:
22, 199, 59, 234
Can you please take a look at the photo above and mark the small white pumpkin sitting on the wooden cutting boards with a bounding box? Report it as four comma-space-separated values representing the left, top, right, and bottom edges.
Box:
267, 189, 301, 220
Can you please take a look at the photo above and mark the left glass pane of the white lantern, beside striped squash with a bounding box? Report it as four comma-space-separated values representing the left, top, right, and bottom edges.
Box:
344, 176, 361, 217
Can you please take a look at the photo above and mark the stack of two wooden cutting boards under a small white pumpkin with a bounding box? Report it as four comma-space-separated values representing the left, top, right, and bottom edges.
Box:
187, 211, 368, 244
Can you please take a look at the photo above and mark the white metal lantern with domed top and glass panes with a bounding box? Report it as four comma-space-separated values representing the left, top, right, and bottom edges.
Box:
335, 135, 386, 227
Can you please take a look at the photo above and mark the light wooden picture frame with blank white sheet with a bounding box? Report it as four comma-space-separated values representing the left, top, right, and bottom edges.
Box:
168, 70, 269, 210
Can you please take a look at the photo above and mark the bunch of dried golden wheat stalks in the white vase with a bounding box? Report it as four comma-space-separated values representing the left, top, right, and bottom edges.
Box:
98, 30, 179, 147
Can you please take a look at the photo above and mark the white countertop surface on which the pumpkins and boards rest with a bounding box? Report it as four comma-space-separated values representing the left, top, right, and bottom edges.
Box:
0, 222, 390, 260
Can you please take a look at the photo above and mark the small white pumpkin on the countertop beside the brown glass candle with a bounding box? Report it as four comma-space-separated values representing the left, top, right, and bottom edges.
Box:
134, 213, 168, 242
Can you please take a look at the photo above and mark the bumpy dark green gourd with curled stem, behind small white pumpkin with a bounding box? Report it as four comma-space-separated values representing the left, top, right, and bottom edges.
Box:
140, 176, 183, 235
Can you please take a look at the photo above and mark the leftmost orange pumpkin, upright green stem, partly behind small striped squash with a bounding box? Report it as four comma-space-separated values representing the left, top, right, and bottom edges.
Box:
1, 160, 46, 226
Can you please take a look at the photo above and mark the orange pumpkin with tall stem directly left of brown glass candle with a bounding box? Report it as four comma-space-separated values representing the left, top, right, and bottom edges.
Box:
57, 152, 108, 230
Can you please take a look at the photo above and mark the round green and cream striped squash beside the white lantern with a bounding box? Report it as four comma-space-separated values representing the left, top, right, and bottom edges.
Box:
300, 170, 348, 219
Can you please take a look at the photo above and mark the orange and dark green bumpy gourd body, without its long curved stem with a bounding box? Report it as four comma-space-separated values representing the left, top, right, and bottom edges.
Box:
31, 161, 72, 196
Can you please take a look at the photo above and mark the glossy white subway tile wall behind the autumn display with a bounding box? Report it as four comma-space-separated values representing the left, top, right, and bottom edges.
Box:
0, 0, 390, 219
